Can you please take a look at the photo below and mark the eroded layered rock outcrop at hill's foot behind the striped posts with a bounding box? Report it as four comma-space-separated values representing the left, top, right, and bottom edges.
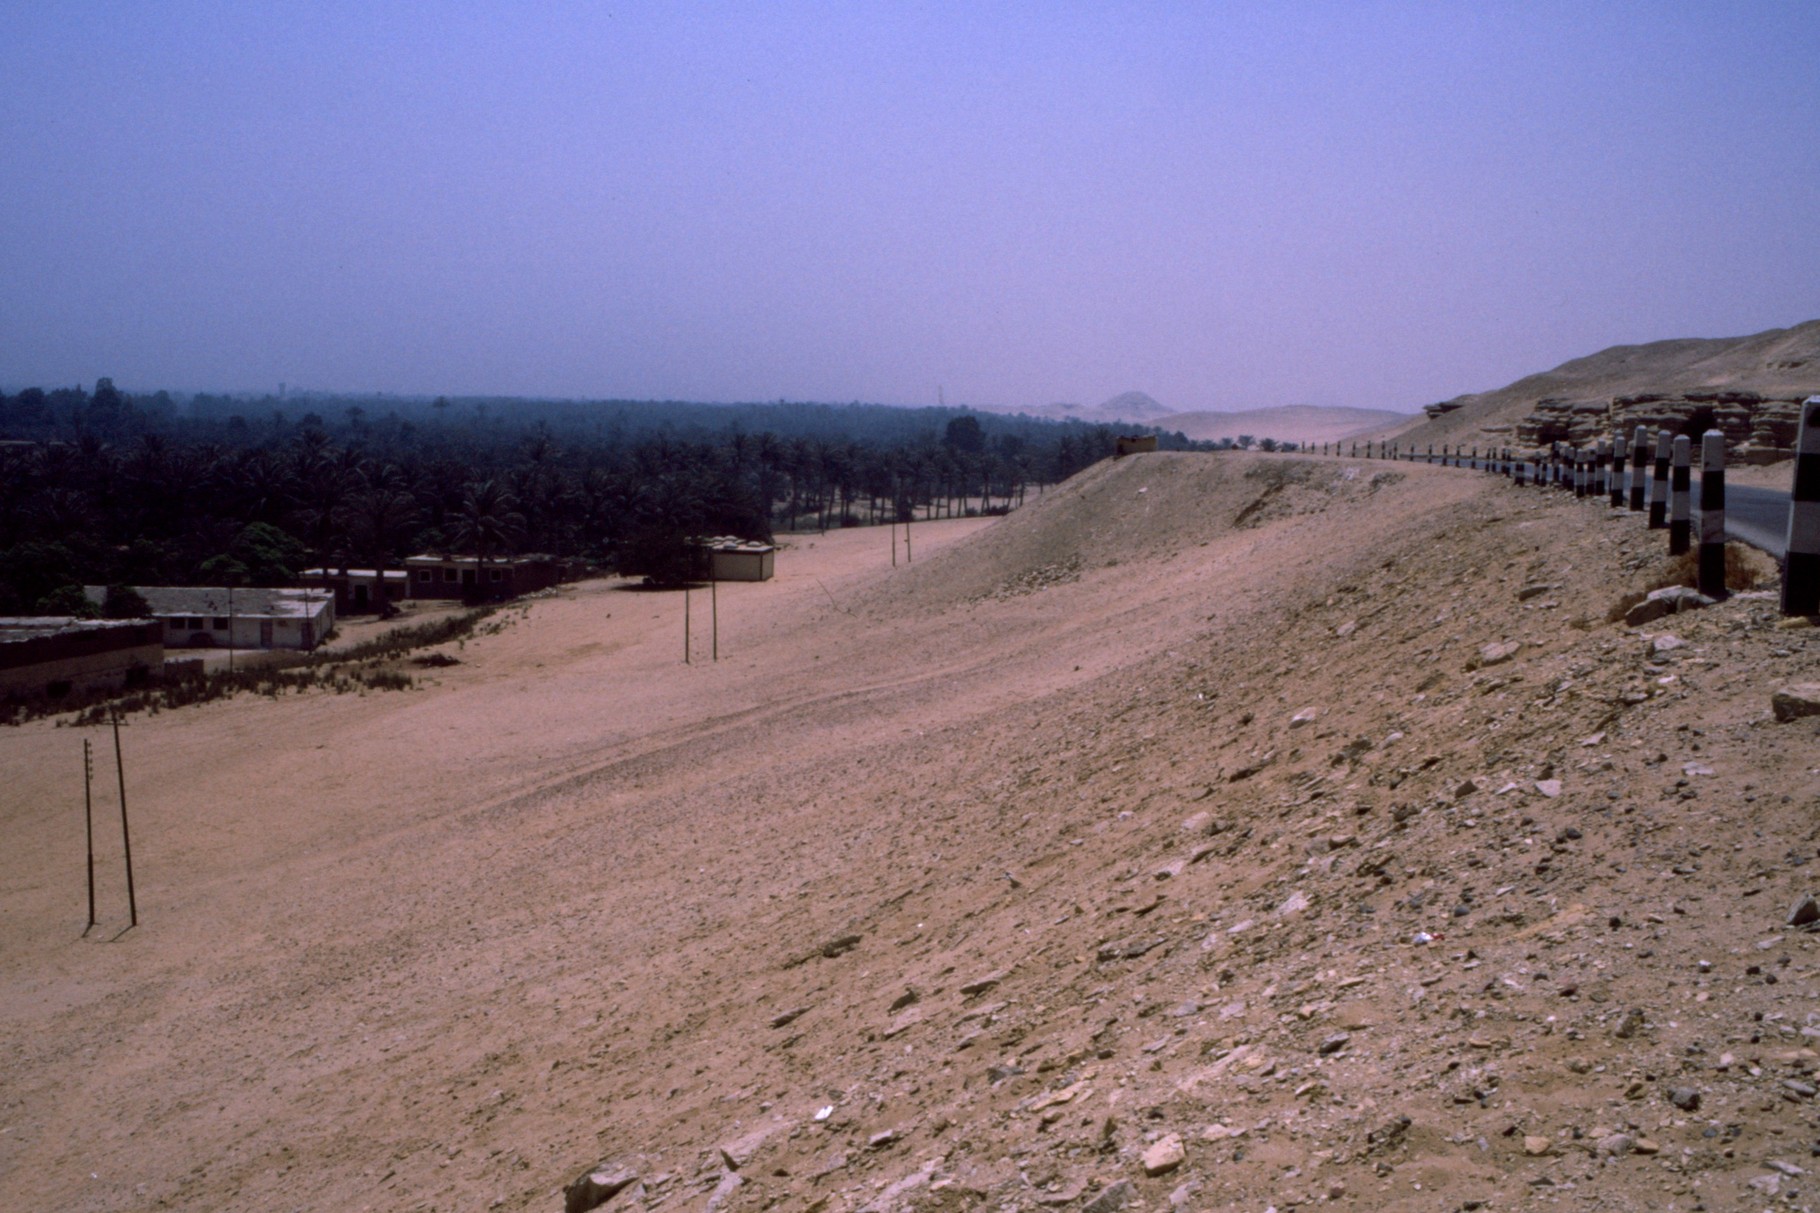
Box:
1516, 390, 1805, 463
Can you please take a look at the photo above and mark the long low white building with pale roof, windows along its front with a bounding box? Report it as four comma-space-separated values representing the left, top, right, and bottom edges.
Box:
84, 585, 335, 652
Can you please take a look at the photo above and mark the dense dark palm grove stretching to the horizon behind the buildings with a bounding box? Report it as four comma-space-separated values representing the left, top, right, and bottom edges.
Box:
0, 379, 1188, 614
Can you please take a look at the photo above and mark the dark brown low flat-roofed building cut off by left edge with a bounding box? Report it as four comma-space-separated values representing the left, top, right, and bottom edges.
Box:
0, 616, 164, 699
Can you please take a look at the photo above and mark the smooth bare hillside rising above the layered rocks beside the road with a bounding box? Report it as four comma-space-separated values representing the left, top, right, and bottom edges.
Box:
1401, 321, 1820, 451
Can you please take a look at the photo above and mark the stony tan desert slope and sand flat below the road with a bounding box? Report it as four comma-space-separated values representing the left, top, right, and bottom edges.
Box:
0, 455, 1820, 1213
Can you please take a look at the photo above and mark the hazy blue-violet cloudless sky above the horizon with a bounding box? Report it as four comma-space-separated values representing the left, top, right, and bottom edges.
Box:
0, 0, 1820, 410
